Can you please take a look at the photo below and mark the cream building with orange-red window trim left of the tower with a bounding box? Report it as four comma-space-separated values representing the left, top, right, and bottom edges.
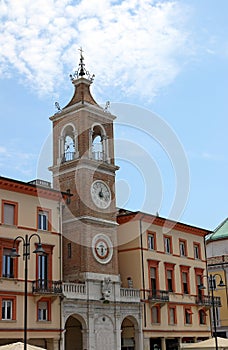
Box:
0, 177, 66, 350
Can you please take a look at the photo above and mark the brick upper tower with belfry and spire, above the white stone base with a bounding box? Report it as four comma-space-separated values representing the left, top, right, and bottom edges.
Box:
50, 50, 118, 281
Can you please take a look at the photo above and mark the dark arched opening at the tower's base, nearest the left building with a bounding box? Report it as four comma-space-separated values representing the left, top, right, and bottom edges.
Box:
65, 316, 84, 350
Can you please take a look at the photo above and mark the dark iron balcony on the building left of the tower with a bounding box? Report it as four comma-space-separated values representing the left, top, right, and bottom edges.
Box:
32, 280, 62, 295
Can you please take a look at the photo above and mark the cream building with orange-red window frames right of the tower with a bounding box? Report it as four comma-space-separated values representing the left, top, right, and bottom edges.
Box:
118, 210, 213, 350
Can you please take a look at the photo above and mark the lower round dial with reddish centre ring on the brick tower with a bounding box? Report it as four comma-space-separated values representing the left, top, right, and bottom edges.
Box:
92, 234, 113, 264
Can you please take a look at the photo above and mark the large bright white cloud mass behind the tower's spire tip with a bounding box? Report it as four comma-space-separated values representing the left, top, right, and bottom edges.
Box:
0, 0, 190, 98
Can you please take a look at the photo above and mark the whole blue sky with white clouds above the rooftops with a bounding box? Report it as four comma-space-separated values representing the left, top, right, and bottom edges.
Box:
0, 0, 228, 230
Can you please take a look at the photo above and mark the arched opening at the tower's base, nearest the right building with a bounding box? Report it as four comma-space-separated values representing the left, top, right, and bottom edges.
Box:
121, 317, 137, 350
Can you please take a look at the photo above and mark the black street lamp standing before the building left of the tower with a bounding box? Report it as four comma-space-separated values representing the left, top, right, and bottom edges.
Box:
10, 233, 45, 350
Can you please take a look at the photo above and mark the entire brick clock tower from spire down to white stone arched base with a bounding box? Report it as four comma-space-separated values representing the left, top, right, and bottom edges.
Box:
50, 50, 141, 350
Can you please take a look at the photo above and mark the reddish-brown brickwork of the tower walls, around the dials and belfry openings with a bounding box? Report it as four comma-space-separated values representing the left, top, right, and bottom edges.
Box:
51, 86, 118, 282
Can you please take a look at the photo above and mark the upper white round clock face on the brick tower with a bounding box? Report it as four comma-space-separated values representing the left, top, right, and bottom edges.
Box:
91, 181, 111, 209
